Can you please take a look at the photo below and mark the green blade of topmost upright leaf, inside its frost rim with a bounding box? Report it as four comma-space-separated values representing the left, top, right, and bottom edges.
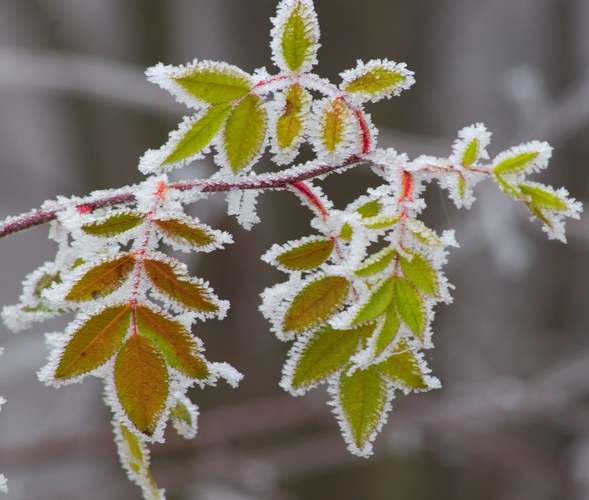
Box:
280, 2, 317, 71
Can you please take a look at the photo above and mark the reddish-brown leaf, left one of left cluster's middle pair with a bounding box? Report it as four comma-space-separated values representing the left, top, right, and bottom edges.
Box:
65, 253, 135, 302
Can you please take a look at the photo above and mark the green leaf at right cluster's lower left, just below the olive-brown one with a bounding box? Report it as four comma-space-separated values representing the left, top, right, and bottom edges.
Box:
292, 324, 375, 389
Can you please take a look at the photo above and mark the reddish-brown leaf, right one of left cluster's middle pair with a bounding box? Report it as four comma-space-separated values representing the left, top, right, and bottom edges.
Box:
143, 259, 219, 313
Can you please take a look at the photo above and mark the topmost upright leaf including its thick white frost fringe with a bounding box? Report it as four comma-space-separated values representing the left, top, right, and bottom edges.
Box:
272, 0, 319, 72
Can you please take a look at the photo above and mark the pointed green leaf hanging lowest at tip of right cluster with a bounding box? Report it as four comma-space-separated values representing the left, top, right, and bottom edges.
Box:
339, 367, 388, 454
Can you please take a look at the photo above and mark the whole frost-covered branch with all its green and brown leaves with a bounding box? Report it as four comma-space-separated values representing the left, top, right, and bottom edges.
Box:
0, 0, 581, 500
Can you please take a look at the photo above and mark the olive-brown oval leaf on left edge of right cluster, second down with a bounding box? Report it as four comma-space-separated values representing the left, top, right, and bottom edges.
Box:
282, 276, 350, 333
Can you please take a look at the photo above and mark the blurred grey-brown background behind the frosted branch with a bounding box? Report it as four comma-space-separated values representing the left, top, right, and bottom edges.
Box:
0, 0, 589, 500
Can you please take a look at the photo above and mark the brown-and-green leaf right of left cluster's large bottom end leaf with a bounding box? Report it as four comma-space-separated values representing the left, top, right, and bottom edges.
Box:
135, 306, 209, 379
